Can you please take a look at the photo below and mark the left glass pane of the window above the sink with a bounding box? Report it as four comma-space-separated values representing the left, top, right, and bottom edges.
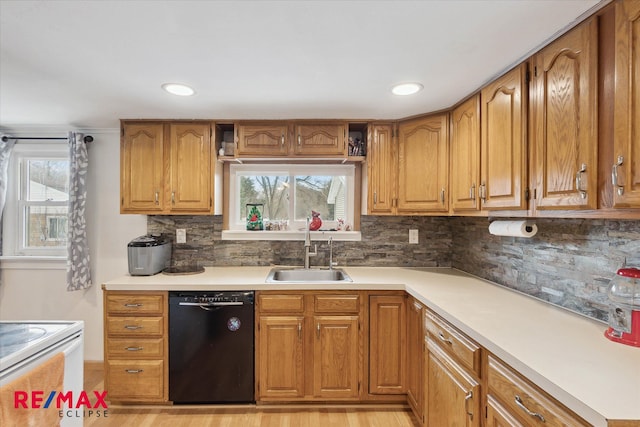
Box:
238, 175, 289, 222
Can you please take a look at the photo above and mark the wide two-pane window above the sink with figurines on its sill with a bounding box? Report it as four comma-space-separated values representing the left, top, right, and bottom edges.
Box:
229, 164, 355, 231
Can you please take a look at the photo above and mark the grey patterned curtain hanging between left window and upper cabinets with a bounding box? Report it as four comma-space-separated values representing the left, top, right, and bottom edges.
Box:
67, 132, 92, 291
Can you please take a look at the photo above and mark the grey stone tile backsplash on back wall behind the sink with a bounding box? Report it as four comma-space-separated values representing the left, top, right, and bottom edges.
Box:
147, 215, 451, 267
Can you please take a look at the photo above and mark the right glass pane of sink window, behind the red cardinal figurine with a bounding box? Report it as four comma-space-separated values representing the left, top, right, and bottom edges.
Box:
295, 175, 347, 222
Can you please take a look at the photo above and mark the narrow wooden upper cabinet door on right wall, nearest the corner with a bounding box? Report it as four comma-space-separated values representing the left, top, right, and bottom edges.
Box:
451, 95, 480, 213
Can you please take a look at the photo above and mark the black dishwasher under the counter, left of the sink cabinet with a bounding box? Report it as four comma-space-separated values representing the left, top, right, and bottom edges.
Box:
169, 291, 255, 403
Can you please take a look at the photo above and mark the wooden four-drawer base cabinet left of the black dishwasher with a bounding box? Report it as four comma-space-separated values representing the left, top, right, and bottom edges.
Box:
104, 291, 169, 403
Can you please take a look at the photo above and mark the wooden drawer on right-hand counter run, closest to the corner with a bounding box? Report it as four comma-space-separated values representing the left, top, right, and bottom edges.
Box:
425, 312, 481, 376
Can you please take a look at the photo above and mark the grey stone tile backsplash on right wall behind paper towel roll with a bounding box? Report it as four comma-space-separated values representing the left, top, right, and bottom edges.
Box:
450, 217, 640, 321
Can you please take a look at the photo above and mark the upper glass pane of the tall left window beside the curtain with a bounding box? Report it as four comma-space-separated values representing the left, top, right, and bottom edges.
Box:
25, 159, 69, 201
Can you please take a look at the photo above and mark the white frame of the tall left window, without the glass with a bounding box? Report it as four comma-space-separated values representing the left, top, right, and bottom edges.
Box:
2, 142, 69, 259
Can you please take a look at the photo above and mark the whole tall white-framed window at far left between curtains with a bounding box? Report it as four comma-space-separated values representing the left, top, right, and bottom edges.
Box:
3, 143, 69, 256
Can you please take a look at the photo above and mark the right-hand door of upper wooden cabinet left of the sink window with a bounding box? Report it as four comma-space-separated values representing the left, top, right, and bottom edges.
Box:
168, 123, 213, 213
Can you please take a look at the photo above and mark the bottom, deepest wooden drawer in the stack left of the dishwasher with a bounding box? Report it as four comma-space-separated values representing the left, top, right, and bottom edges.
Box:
107, 360, 164, 400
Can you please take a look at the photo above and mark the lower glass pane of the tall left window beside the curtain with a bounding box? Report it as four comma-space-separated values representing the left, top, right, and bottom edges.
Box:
24, 205, 68, 248
